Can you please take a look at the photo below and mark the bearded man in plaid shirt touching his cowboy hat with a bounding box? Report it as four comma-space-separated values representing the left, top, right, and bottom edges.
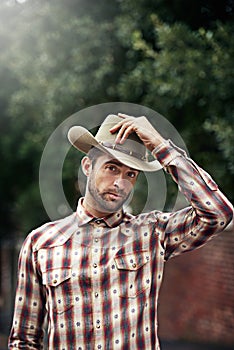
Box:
9, 114, 232, 350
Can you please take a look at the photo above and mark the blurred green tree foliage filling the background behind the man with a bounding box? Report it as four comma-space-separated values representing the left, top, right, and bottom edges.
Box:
0, 0, 234, 235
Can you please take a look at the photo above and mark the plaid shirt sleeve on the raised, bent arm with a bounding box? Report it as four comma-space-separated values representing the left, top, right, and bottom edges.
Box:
152, 141, 233, 260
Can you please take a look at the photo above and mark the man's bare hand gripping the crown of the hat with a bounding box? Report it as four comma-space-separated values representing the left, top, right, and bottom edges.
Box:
110, 113, 165, 151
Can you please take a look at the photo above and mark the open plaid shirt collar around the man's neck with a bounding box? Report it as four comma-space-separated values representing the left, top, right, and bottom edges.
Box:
76, 198, 124, 227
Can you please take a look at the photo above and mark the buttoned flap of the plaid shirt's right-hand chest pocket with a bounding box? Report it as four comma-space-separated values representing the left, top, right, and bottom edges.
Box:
114, 251, 150, 271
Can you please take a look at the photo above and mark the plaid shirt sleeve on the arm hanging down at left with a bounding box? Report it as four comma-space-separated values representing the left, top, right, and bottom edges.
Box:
8, 235, 45, 349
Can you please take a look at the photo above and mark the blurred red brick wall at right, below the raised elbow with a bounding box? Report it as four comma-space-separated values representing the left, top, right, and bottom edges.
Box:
159, 227, 234, 345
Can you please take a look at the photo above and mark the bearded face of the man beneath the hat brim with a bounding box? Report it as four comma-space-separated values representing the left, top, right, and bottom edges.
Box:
83, 155, 139, 214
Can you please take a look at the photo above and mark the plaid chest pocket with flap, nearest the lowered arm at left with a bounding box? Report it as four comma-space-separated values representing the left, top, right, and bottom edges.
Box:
42, 267, 73, 314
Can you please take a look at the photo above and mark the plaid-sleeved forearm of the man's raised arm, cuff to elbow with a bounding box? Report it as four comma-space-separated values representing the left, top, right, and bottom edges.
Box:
152, 141, 233, 233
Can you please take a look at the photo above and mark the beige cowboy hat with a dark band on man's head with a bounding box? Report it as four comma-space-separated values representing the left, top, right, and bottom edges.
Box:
68, 114, 162, 171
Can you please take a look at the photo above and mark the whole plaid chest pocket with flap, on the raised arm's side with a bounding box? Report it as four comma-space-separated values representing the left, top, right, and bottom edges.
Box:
114, 251, 151, 298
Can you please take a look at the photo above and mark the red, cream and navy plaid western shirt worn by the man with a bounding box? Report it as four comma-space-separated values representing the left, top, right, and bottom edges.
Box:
9, 142, 232, 350
